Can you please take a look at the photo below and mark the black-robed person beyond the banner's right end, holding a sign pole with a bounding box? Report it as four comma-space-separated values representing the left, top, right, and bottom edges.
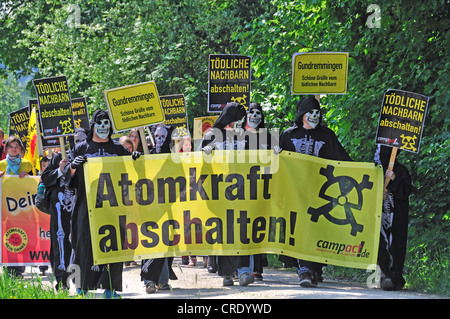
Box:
374, 145, 413, 290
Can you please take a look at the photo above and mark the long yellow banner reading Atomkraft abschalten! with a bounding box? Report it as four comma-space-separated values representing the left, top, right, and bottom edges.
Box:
85, 151, 383, 269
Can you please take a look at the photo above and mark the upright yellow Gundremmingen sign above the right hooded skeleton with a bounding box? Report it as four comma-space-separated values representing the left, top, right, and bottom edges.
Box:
291, 52, 348, 94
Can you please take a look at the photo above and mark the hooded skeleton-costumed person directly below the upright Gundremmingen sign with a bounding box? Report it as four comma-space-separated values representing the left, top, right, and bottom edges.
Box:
279, 96, 352, 287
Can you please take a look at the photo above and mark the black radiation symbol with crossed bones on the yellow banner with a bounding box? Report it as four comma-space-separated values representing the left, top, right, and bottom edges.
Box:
308, 165, 373, 236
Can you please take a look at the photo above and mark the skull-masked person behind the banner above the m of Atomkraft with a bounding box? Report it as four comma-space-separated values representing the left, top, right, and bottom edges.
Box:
136, 124, 178, 294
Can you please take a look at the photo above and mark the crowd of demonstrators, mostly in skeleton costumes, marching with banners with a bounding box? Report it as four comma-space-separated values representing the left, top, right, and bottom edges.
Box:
0, 96, 412, 298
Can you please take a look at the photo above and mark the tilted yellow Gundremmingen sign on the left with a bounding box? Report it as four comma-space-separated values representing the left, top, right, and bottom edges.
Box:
103, 81, 165, 132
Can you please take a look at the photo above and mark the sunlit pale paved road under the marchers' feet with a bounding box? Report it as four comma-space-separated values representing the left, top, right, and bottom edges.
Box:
26, 258, 439, 300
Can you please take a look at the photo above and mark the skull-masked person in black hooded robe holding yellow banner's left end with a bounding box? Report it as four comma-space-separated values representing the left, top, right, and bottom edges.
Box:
63, 109, 130, 298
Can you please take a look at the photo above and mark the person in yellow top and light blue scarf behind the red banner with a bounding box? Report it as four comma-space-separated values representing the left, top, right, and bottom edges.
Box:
0, 135, 33, 277
